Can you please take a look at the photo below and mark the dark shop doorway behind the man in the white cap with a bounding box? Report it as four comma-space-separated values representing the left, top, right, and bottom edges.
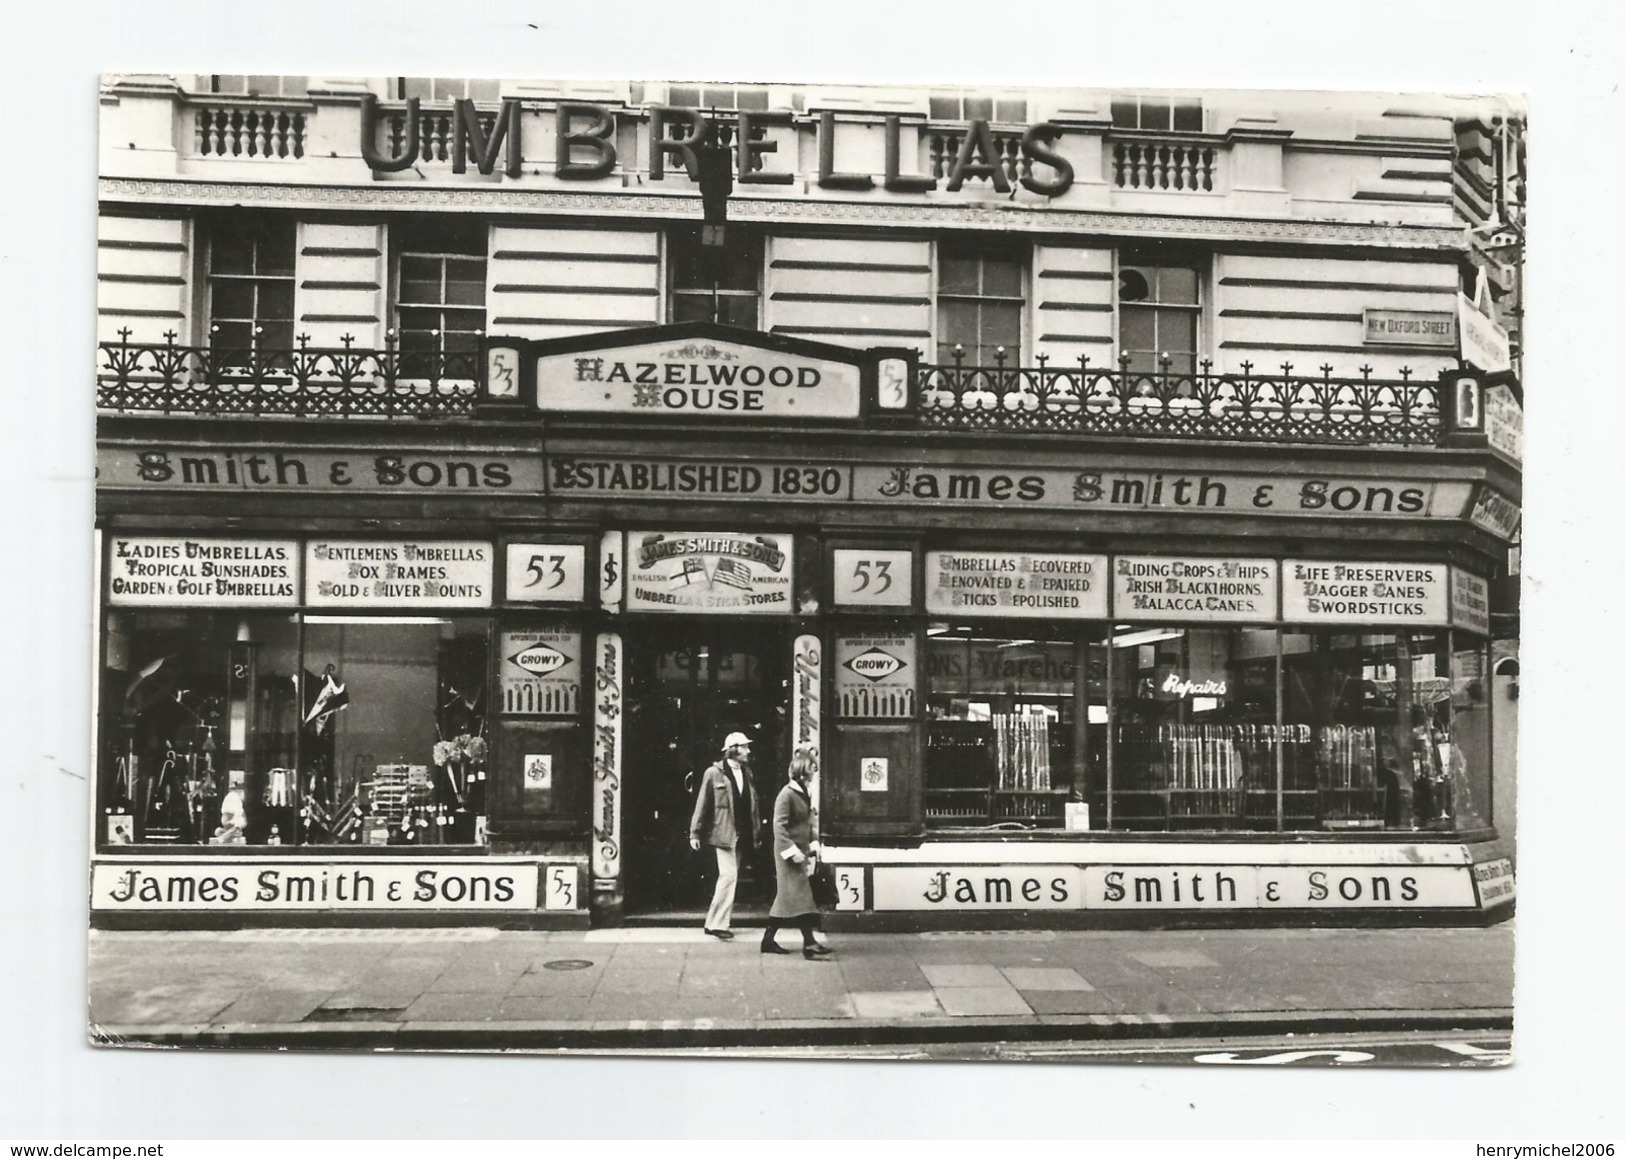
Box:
622, 624, 790, 918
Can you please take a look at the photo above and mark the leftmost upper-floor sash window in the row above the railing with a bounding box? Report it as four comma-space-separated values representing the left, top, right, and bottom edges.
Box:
203, 219, 294, 364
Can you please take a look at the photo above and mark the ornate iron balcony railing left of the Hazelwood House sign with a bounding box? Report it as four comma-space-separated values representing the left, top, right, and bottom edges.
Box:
96, 332, 479, 418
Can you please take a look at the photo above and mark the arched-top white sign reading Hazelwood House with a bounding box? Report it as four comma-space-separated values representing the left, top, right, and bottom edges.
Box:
536, 338, 863, 418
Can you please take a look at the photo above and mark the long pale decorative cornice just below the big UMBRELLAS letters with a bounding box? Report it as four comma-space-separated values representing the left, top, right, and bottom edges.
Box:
99, 177, 1467, 250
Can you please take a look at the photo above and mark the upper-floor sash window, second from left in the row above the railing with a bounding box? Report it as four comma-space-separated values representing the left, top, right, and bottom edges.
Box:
392, 218, 486, 375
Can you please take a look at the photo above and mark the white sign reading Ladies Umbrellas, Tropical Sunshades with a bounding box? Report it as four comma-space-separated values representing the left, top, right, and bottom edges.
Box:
107, 535, 299, 608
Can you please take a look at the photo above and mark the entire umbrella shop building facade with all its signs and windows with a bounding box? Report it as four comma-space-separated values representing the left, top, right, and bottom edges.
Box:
91, 78, 1521, 928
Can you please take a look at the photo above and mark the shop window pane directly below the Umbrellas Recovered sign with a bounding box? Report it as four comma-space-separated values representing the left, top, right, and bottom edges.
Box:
925, 624, 1105, 827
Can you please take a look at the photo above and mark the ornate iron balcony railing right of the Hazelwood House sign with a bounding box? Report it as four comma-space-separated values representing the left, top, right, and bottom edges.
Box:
920, 356, 1440, 445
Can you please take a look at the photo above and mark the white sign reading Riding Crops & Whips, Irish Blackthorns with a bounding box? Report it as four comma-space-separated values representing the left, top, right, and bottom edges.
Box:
1112, 556, 1281, 623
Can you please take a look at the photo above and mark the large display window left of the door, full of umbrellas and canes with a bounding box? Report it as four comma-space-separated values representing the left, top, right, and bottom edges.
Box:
99, 610, 489, 847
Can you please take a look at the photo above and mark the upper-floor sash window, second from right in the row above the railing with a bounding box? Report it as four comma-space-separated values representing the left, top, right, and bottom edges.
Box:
936, 244, 1025, 366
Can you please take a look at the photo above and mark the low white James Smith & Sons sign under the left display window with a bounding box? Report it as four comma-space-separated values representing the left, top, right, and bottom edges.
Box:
91, 858, 546, 914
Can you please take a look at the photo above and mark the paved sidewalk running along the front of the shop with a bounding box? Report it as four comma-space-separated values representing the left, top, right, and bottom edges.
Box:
89, 922, 1513, 1050
